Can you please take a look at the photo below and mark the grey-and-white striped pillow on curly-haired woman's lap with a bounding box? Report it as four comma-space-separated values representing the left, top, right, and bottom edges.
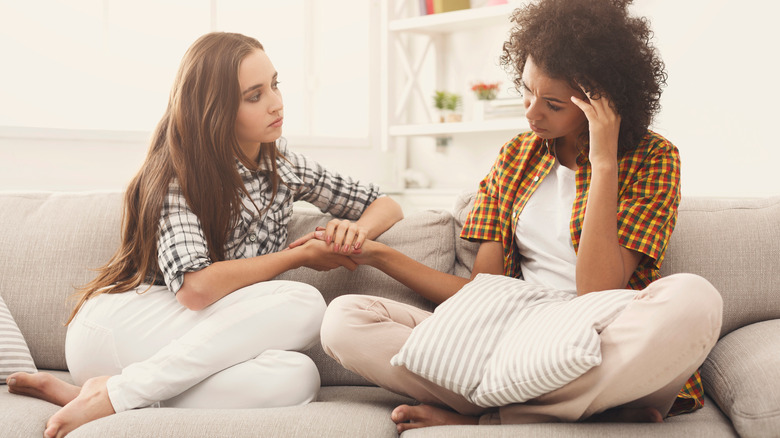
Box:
391, 274, 635, 407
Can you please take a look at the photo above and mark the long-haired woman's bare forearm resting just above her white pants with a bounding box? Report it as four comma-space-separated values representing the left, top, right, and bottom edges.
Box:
176, 248, 305, 310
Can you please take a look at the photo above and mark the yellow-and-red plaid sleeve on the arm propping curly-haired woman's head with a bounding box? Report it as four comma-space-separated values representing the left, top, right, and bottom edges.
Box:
618, 133, 680, 269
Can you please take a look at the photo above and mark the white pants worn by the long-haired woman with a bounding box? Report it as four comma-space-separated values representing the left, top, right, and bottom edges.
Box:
65, 281, 325, 412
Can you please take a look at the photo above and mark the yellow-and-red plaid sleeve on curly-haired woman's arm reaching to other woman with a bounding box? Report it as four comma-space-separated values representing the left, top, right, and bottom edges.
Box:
460, 145, 506, 242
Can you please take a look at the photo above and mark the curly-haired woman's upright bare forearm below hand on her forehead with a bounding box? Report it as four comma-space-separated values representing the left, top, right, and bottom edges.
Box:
576, 163, 628, 295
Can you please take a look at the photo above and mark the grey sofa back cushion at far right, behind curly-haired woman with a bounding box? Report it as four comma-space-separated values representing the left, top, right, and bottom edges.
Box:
661, 197, 780, 335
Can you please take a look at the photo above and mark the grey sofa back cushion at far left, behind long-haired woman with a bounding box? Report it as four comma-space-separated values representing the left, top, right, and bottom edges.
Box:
0, 192, 122, 370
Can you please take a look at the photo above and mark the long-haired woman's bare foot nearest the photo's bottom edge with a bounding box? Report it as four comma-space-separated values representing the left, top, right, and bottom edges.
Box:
43, 376, 115, 438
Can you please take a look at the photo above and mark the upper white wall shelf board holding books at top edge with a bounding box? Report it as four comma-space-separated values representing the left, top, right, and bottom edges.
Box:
388, 2, 518, 35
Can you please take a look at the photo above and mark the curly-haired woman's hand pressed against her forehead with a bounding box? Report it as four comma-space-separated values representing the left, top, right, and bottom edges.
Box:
571, 87, 620, 165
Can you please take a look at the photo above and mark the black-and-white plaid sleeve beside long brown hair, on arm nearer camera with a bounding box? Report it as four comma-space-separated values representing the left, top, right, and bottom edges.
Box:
157, 185, 211, 293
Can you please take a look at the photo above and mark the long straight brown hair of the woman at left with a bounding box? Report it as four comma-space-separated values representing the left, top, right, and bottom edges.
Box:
68, 32, 279, 323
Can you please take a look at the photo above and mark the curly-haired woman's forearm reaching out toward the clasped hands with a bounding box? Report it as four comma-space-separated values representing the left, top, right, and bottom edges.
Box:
366, 241, 469, 304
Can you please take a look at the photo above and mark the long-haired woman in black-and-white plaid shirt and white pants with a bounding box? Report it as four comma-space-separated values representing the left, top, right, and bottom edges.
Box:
7, 33, 403, 437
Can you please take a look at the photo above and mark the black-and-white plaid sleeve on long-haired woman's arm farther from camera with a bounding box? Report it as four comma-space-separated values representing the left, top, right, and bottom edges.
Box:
284, 151, 384, 220
